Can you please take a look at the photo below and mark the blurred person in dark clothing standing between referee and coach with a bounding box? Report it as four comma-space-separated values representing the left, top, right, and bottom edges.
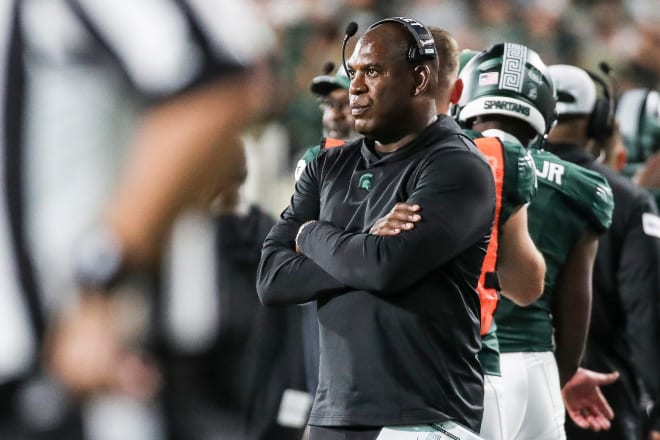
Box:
155, 144, 306, 440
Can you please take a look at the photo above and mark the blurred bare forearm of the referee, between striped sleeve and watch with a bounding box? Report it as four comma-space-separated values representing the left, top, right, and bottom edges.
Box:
106, 75, 254, 267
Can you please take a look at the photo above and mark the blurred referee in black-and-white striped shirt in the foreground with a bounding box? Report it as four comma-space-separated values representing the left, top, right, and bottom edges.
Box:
3, 0, 270, 438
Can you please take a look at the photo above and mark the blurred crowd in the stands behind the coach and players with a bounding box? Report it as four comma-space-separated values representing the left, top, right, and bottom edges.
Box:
251, 0, 660, 217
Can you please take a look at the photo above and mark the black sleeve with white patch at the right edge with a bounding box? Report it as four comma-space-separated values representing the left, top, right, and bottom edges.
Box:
616, 192, 660, 393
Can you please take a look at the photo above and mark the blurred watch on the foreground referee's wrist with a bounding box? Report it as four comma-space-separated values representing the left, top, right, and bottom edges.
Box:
74, 228, 122, 287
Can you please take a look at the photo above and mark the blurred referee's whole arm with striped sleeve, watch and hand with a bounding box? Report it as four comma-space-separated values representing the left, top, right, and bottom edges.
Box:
46, 1, 274, 398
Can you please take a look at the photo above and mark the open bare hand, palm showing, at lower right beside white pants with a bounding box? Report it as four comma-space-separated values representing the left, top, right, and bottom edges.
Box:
561, 368, 619, 431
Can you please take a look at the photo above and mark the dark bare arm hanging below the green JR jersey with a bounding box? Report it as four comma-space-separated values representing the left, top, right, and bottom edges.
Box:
552, 231, 598, 386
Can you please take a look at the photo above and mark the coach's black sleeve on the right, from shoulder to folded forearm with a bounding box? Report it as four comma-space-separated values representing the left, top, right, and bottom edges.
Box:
298, 150, 495, 293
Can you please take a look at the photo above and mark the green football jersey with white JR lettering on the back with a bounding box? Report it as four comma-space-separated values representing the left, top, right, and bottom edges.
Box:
495, 150, 614, 353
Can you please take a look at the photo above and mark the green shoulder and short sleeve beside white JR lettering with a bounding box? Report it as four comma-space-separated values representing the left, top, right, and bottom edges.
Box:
531, 150, 614, 233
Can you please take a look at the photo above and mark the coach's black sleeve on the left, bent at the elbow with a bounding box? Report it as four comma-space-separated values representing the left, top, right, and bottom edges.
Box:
257, 161, 345, 304
